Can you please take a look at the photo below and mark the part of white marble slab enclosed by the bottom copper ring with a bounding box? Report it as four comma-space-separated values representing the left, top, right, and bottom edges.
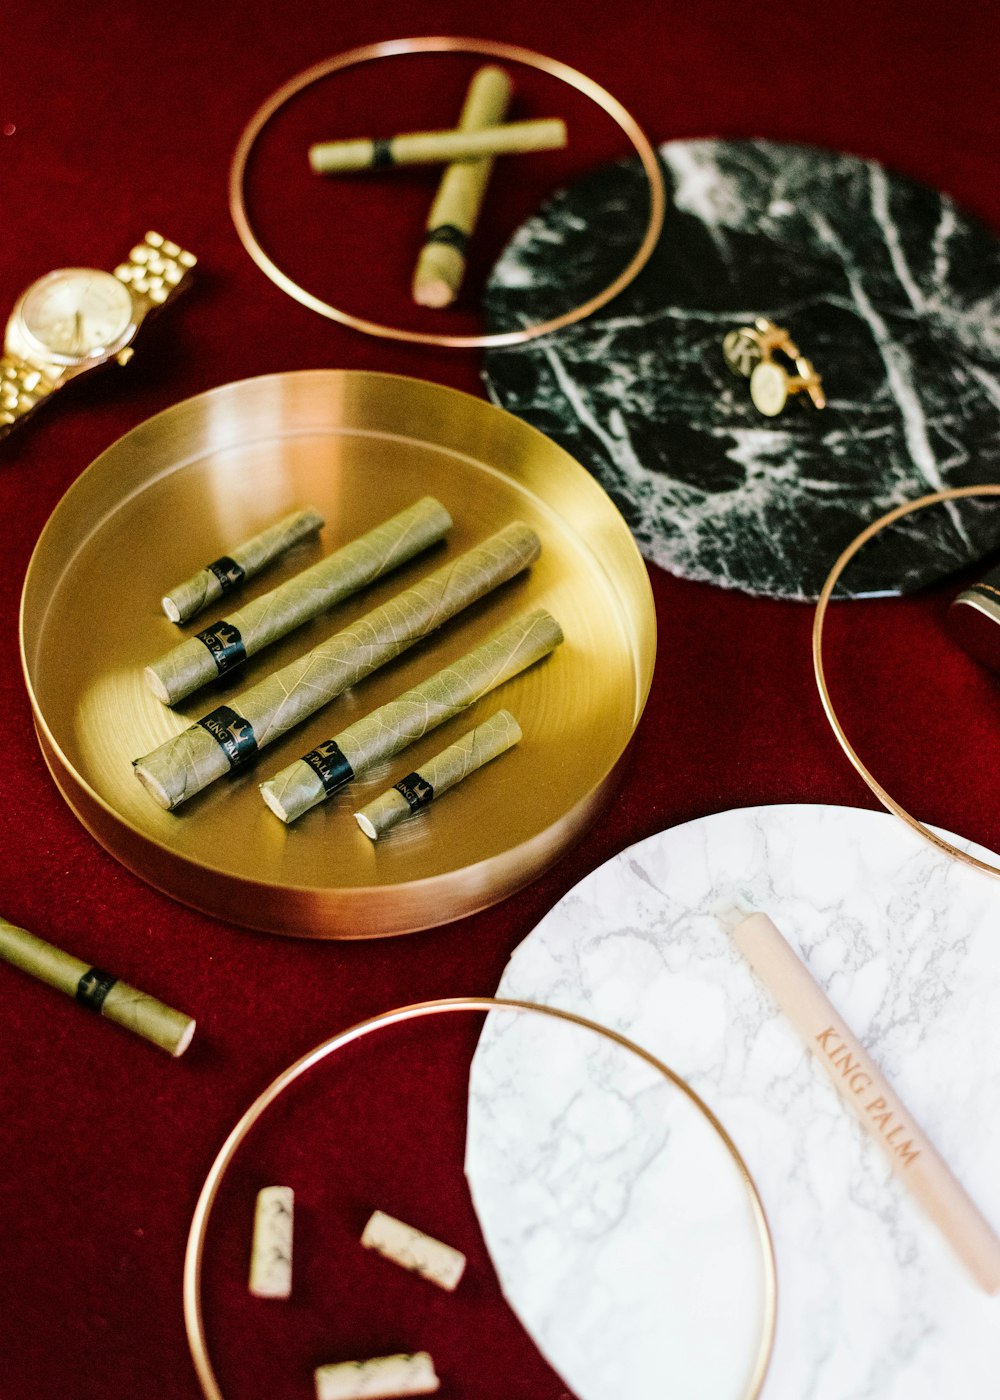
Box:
466, 1012, 768, 1400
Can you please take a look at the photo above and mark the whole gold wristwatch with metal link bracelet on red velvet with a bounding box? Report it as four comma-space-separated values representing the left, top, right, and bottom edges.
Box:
0, 234, 197, 438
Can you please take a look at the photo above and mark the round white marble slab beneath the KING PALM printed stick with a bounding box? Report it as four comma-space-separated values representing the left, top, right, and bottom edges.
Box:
466, 805, 1000, 1400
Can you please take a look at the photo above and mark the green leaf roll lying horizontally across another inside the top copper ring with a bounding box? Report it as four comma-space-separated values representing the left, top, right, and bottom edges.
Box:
310, 116, 566, 175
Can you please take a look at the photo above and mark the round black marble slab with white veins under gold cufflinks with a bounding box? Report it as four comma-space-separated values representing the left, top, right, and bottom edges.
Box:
485, 140, 1000, 599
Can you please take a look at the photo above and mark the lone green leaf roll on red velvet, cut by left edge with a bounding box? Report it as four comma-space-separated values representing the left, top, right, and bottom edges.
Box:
0, 918, 195, 1058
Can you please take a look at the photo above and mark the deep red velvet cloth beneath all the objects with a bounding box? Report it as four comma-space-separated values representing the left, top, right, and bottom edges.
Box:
0, 0, 1000, 1400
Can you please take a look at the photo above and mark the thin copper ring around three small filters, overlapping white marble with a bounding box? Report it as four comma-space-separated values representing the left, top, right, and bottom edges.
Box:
183, 997, 777, 1400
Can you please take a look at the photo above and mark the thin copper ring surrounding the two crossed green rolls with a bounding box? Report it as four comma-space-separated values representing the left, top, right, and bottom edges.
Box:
230, 35, 667, 350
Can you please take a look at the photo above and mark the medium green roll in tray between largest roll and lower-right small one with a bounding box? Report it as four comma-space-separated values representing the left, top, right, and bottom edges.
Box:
261, 608, 551, 822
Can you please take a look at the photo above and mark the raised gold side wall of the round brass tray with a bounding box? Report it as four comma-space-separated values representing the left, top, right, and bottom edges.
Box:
20, 370, 657, 938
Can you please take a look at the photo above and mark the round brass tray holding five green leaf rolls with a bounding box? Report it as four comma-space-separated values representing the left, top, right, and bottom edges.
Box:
21, 370, 655, 938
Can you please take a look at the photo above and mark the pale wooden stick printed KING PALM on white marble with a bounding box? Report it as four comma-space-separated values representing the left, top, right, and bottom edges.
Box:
732, 914, 1000, 1294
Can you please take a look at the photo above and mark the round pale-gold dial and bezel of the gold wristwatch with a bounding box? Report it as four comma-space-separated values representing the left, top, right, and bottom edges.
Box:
21, 267, 132, 364
